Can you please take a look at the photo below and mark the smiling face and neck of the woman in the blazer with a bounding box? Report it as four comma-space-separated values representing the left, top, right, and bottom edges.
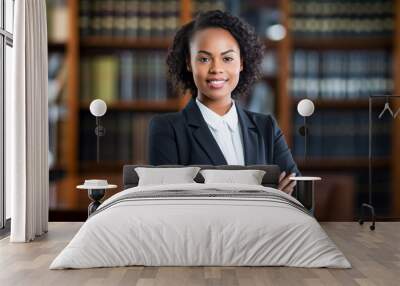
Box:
187, 28, 243, 103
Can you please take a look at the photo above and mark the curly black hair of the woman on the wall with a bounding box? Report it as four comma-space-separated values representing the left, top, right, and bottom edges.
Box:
167, 10, 264, 98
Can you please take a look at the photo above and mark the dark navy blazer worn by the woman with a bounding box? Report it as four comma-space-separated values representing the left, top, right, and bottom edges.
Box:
149, 99, 300, 175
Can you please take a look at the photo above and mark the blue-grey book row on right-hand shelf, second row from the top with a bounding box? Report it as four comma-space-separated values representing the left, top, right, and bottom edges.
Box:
290, 49, 394, 100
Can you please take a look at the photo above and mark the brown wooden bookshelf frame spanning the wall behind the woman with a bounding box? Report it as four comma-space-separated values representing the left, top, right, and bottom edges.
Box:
49, 0, 400, 217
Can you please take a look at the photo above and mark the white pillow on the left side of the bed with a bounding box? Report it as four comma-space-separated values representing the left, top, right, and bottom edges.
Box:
135, 167, 200, 186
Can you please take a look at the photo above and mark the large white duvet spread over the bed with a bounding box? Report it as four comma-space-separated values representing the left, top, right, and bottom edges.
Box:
50, 183, 351, 269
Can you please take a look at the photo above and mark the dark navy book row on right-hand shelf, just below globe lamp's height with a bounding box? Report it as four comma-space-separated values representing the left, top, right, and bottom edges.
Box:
292, 110, 392, 159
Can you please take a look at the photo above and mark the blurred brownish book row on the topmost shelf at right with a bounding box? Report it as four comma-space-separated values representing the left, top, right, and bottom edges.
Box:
289, 0, 395, 37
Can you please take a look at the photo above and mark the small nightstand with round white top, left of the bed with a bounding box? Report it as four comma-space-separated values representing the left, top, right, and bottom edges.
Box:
76, 180, 117, 217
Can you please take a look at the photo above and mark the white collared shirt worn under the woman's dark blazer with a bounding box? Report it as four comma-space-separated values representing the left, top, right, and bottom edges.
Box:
196, 99, 245, 165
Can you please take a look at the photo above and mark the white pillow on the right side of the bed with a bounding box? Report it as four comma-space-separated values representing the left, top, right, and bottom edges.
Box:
200, 170, 265, 185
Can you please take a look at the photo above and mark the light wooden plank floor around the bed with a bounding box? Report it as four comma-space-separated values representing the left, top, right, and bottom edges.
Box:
0, 222, 400, 286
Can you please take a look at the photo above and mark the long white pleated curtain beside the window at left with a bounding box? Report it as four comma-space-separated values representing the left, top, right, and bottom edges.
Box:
6, 0, 49, 242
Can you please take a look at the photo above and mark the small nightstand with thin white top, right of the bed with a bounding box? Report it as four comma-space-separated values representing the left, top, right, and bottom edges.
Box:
289, 177, 321, 215
